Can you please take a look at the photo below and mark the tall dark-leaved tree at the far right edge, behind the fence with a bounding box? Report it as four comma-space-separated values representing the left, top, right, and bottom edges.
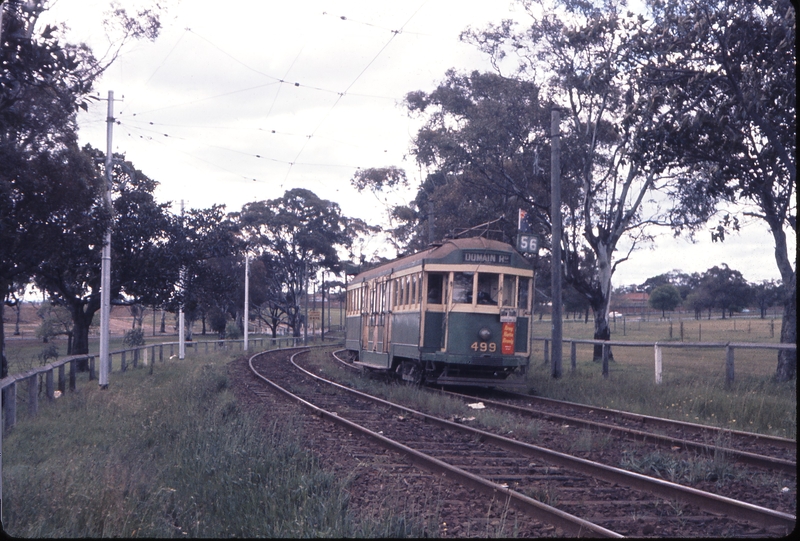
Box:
638, 0, 797, 381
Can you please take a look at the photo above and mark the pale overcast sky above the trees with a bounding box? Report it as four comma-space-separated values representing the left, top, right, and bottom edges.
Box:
40, 0, 795, 286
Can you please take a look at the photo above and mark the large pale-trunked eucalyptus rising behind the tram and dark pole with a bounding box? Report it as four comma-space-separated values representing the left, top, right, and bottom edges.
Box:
366, 0, 713, 358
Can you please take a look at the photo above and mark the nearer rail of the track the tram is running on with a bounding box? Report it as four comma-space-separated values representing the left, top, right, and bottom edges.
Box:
440, 391, 797, 475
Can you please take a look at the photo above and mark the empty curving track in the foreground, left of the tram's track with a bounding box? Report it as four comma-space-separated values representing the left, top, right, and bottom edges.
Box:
250, 346, 795, 537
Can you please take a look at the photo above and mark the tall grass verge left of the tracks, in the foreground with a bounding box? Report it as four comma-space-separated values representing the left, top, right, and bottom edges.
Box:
2, 355, 422, 537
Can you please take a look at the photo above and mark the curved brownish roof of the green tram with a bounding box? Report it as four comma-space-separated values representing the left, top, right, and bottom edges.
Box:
351, 237, 531, 283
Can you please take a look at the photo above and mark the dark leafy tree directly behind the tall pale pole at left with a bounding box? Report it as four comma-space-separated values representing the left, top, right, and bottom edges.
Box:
35, 146, 178, 354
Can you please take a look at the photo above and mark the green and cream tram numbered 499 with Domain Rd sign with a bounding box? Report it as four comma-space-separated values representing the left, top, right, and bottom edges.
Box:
345, 237, 533, 386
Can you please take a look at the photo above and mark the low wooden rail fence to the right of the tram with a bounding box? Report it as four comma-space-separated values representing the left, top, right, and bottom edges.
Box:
531, 337, 797, 384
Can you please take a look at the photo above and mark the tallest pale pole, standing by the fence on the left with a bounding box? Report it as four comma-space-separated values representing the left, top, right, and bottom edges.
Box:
99, 90, 114, 389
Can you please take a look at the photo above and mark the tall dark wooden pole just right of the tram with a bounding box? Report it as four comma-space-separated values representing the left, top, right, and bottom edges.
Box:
550, 109, 562, 378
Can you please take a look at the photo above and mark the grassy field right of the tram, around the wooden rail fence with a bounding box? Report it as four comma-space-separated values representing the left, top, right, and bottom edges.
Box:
527, 319, 797, 439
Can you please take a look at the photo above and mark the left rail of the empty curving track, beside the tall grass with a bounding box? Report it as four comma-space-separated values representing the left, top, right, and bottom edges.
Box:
249, 350, 624, 538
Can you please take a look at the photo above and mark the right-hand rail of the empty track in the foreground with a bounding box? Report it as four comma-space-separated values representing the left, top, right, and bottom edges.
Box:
322, 350, 797, 534
